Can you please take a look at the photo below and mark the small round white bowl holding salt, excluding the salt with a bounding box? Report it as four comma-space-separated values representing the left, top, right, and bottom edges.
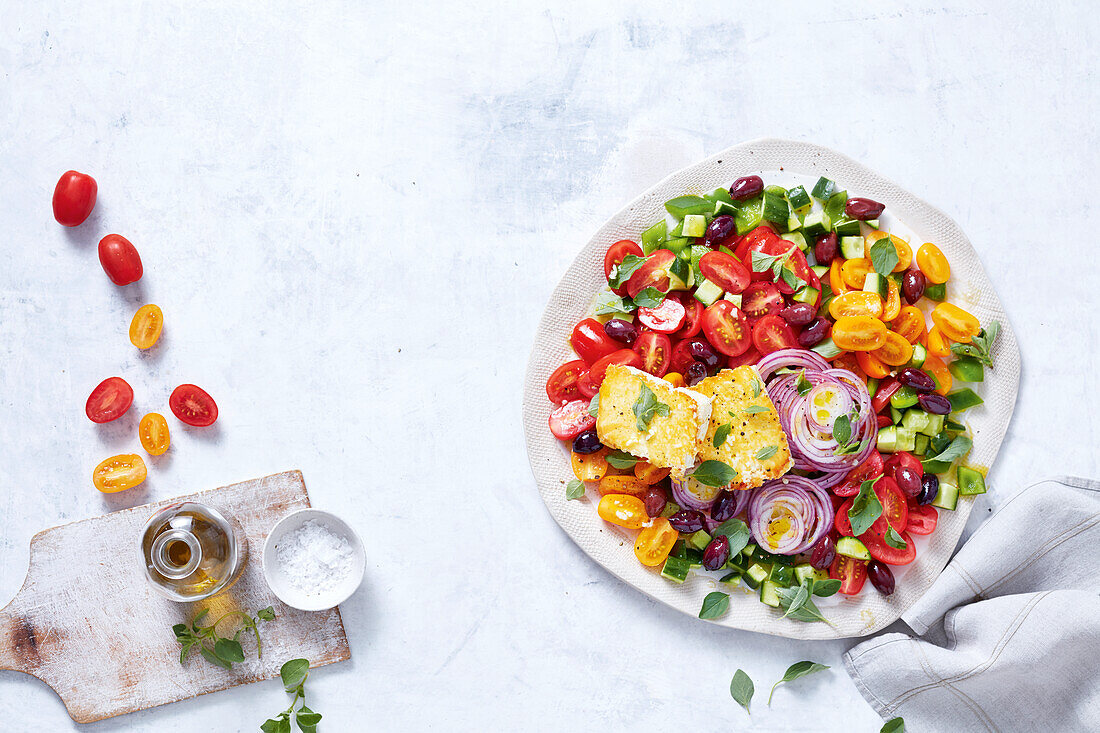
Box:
263, 508, 366, 611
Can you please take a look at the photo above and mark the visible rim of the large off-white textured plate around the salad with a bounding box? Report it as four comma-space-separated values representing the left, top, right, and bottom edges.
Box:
524, 139, 1020, 638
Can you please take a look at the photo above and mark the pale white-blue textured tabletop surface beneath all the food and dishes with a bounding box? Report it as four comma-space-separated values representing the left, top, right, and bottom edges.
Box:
0, 0, 1100, 733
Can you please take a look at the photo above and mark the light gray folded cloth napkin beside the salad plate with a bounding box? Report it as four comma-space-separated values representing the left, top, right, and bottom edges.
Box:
845, 478, 1100, 733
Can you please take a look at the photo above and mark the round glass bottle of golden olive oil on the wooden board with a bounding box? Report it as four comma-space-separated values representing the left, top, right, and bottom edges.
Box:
141, 502, 245, 601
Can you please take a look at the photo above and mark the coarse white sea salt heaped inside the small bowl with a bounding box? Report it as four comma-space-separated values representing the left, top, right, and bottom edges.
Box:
275, 519, 354, 595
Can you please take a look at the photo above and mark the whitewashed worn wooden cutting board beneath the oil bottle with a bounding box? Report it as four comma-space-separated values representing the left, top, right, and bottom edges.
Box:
0, 471, 351, 724
